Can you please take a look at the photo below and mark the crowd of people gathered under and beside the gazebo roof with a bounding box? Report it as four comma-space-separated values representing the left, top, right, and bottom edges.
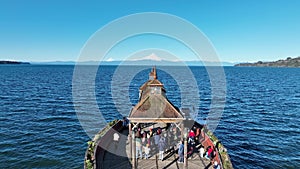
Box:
118, 117, 219, 168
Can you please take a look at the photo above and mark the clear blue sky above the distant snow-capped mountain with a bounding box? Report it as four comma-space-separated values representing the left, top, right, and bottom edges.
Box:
0, 0, 300, 62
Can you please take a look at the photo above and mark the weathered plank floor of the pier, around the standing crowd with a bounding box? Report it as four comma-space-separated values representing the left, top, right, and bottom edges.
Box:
97, 130, 212, 169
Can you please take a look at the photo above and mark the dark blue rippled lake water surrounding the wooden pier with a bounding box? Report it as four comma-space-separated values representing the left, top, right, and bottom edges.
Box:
0, 65, 300, 169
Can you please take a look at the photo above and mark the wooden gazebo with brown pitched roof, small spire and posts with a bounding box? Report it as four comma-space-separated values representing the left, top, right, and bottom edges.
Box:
128, 67, 187, 168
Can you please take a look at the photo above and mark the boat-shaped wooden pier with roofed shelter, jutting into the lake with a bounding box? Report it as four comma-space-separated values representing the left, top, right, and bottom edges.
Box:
85, 67, 232, 169
